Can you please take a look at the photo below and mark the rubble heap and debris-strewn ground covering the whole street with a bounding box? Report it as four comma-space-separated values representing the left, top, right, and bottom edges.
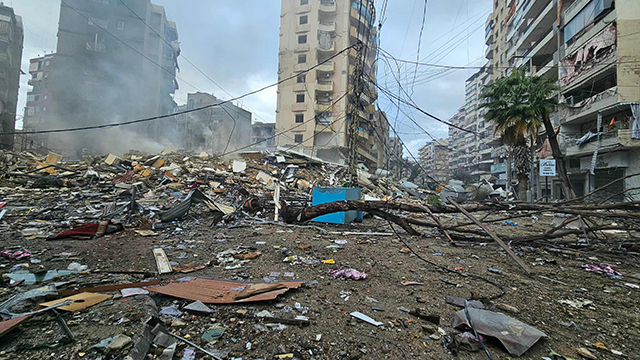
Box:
0, 152, 640, 359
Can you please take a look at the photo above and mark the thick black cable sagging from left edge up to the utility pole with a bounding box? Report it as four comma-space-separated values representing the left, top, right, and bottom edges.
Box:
0, 46, 353, 135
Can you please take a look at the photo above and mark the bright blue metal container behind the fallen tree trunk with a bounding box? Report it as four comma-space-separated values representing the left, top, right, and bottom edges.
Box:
311, 186, 362, 224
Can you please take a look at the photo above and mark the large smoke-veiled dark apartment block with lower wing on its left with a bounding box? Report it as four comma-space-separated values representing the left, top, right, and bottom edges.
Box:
22, 0, 180, 157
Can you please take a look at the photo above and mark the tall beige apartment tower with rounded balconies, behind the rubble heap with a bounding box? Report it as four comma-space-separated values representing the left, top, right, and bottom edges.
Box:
276, 0, 388, 167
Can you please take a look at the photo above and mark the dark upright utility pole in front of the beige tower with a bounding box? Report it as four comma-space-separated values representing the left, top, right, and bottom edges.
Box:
347, 41, 364, 187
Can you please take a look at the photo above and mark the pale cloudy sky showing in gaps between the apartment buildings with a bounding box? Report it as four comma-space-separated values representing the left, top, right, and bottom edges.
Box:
11, 0, 491, 157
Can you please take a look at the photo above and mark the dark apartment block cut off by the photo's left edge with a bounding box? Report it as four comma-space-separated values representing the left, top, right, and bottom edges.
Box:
0, 3, 24, 150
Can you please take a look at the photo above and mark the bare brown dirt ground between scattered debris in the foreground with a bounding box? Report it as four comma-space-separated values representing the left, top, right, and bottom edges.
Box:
0, 212, 640, 359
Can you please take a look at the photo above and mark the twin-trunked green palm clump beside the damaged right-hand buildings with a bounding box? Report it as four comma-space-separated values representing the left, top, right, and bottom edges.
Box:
481, 70, 575, 200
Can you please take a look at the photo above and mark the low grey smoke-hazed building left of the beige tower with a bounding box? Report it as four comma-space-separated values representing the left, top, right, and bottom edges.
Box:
174, 92, 252, 154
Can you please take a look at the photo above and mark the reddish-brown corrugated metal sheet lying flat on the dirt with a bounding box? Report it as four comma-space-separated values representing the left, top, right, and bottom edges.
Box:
145, 278, 304, 304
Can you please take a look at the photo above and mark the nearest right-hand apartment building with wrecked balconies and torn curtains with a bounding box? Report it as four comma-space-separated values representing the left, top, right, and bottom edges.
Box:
550, 0, 640, 201
